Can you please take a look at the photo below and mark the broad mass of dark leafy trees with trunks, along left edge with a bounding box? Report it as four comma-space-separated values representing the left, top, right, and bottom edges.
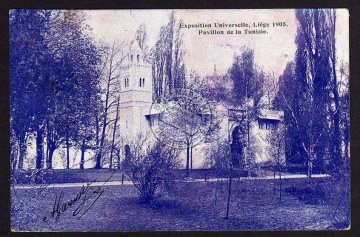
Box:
10, 10, 100, 169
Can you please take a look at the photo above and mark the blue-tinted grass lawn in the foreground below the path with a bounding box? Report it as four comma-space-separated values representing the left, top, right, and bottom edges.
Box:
11, 171, 349, 231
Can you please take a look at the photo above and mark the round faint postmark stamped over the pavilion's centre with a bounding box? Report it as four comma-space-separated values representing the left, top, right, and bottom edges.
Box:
150, 88, 212, 149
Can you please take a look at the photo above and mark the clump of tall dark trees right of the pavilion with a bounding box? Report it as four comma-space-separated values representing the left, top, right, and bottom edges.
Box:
275, 9, 348, 175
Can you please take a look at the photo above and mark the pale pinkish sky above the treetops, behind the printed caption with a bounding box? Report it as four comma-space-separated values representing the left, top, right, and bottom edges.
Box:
86, 9, 349, 77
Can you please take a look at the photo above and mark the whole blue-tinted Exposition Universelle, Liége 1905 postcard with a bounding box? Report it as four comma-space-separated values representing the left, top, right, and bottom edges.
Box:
9, 9, 351, 232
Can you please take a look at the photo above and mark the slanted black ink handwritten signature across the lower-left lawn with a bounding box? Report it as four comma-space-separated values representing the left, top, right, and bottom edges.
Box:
43, 172, 115, 222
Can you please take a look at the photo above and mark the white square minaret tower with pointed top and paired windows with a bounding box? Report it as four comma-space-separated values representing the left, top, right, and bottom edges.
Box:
119, 40, 152, 142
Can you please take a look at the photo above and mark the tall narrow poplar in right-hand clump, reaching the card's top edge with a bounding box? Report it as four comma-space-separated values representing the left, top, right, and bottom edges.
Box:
295, 10, 331, 176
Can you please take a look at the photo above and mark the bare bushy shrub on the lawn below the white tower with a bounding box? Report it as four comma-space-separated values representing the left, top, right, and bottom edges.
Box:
123, 135, 180, 204
